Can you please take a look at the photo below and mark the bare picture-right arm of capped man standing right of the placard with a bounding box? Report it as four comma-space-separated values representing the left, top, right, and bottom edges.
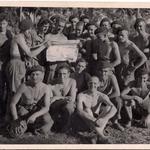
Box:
111, 42, 121, 67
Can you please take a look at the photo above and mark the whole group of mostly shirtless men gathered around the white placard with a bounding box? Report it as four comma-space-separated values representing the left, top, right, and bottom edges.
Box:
0, 11, 150, 143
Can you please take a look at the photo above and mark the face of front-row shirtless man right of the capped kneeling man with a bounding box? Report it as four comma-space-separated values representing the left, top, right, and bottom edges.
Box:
58, 68, 70, 82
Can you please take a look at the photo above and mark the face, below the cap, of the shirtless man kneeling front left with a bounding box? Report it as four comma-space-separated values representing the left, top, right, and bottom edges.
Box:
30, 71, 44, 84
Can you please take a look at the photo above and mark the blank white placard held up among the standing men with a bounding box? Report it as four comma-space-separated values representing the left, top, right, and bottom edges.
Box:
46, 40, 79, 62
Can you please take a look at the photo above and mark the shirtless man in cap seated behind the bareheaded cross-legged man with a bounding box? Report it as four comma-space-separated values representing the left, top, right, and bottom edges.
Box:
97, 61, 124, 131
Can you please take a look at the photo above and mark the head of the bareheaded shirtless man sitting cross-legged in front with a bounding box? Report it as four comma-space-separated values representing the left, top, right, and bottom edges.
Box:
88, 76, 100, 92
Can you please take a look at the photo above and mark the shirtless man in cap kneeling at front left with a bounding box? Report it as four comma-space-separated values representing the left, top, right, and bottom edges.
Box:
10, 66, 52, 134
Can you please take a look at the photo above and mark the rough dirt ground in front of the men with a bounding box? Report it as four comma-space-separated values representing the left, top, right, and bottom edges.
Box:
0, 119, 150, 144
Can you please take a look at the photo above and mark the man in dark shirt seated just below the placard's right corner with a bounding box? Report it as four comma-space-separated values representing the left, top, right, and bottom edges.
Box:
71, 59, 90, 93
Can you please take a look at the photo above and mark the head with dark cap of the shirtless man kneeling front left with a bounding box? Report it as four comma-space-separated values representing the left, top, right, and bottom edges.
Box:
27, 65, 44, 84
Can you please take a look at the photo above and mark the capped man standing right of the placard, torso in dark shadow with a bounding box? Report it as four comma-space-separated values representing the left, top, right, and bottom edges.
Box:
92, 27, 121, 72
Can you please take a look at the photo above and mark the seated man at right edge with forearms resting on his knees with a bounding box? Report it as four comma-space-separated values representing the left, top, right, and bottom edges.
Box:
121, 69, 150, 127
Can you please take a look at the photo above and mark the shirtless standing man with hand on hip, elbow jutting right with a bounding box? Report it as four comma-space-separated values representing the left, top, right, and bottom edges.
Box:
116, 28, 147, 90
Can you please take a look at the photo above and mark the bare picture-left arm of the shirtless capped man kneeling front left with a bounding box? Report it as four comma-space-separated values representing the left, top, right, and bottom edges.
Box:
10, 84, 25, 120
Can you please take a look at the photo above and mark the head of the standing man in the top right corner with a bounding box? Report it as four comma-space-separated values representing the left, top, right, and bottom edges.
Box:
134, 18, 146, 33
